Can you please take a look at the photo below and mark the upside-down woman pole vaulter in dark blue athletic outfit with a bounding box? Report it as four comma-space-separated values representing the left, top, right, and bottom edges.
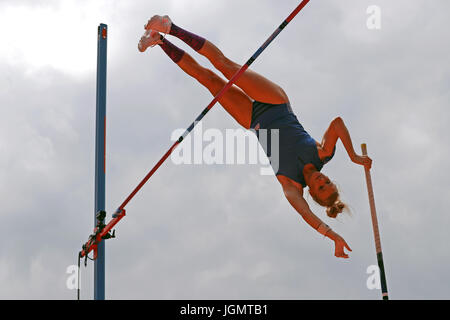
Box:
138, 15, 372, 258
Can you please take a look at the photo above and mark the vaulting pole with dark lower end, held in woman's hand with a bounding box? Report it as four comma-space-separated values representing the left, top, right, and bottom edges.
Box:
361, 143, 389, 300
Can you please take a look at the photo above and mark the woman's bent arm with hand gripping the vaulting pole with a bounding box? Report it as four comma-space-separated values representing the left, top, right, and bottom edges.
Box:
319, 117, 372, 169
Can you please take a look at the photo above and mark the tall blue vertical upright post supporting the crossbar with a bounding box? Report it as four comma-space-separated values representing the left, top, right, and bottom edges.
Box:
94, 24, 108, 300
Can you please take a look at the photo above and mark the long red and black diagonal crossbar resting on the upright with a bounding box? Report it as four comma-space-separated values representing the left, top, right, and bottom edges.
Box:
80, 0, 309, 257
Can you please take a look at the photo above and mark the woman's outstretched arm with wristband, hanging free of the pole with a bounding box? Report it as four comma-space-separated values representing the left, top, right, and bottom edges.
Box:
282, 183, 352, 258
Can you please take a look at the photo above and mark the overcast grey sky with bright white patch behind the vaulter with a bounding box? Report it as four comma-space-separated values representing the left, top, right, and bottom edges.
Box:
0, 0, 450, 299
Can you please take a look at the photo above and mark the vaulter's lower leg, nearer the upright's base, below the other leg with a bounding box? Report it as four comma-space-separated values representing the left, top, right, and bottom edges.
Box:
139, 32, 253, 129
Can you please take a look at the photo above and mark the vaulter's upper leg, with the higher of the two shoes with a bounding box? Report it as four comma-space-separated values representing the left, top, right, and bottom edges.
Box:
145, 16, 289, 104
